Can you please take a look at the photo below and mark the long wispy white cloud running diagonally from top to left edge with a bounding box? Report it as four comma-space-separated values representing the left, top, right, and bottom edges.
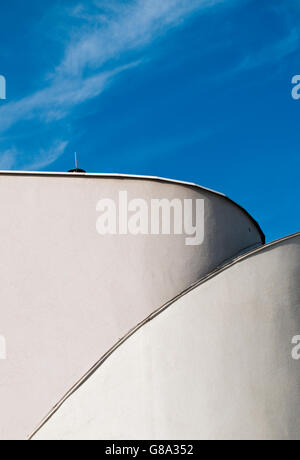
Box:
0, 0, 222, 137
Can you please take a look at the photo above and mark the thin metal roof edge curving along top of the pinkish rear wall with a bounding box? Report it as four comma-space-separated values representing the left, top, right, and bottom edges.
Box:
0, 171, 266, 245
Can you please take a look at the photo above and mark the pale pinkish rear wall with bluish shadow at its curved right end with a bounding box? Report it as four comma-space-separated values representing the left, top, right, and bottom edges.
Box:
0, 173, 262, 439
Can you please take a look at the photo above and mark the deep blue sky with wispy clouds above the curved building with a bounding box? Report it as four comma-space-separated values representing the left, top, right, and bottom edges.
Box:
0, 0, 300, 241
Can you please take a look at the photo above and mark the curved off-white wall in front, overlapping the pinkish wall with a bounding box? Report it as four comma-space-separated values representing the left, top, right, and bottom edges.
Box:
34, 235, 300, 440
